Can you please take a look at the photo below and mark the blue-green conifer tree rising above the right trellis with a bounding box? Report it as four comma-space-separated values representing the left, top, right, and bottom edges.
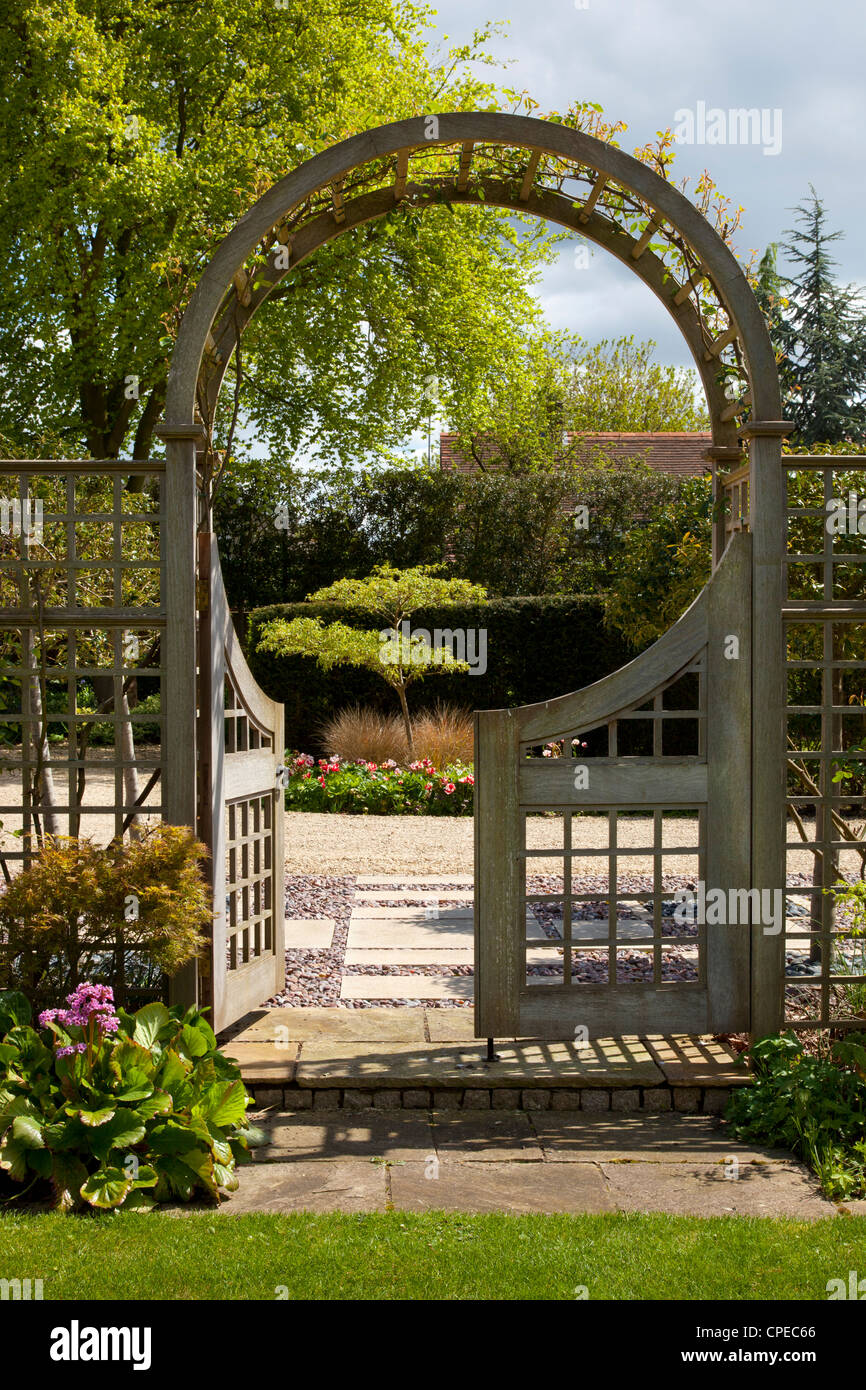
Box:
778, 185, 866, 448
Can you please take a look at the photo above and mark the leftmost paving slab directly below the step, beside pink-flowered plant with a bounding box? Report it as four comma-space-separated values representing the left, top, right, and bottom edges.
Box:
253, 1109, 435, 1163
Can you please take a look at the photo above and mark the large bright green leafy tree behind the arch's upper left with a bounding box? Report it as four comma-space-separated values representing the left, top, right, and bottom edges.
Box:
0, 0, 556, 457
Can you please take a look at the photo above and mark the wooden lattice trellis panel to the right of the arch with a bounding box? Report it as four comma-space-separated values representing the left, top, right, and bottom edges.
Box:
783, 455, 866, 1029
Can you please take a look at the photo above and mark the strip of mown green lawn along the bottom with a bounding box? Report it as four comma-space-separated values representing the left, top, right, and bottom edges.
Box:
0, 1212, 866, 1301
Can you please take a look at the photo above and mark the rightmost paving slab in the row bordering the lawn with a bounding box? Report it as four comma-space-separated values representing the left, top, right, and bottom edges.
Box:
601, 1162, 835, 1220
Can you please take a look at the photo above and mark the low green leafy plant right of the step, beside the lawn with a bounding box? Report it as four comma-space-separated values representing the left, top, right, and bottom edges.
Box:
727, 1033, 866, 1201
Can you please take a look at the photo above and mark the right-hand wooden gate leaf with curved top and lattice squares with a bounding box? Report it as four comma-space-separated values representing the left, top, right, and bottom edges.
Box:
475, 532, 766, 1038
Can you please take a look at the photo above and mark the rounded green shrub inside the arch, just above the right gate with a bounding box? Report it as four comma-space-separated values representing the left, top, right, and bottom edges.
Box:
606, 478, 713, 646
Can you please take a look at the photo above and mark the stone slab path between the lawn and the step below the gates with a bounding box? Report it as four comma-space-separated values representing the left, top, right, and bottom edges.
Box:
221, 1111, 845, 1219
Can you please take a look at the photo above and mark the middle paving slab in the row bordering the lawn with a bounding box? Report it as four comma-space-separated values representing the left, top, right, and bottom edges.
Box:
391, 1162, 614, 1215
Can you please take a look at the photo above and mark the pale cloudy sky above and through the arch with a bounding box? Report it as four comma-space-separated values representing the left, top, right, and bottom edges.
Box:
430, 0, 866, 366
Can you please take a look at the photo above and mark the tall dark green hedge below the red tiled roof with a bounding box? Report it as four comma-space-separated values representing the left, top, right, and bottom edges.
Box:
215, 461, 697, 609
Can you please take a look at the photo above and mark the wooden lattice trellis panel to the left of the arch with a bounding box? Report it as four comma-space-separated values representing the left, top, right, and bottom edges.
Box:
0, 460, 165, 872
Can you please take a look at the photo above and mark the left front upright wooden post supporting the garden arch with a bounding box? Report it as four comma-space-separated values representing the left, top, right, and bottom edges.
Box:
156, 424, 203, 1005
